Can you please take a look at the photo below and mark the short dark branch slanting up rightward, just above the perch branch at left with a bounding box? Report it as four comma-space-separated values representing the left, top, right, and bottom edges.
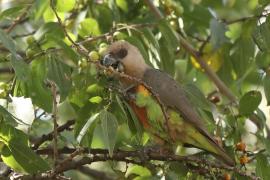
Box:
32, 120, 75, 150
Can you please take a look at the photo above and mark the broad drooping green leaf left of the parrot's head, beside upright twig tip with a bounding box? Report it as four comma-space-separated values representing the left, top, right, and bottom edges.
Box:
47, 55, 72, 102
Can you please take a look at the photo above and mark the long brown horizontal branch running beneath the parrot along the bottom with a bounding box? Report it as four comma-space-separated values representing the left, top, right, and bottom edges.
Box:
37, 147, 259, 180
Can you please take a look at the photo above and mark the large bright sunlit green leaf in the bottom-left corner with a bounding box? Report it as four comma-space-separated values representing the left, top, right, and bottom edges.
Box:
0, 123, 49, 174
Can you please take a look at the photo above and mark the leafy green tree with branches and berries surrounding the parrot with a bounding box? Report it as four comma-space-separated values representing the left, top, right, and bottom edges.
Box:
0, 0, 270, 180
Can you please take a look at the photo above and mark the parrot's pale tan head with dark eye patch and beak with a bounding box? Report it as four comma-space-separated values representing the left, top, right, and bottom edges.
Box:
102, 40, 148, 78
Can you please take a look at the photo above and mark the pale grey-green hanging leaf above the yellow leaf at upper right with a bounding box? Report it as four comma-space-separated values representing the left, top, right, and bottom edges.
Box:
210, 19, 228, 49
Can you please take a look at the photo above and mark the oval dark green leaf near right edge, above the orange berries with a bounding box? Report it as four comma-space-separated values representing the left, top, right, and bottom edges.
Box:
239, 91, 262, 115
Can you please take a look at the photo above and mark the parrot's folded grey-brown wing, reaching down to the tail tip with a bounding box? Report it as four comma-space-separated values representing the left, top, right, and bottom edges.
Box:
142, 68, 234, 165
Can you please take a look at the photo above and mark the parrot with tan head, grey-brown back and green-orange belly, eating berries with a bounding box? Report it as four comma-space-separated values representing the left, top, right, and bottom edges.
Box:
101, 40, 235, 166
